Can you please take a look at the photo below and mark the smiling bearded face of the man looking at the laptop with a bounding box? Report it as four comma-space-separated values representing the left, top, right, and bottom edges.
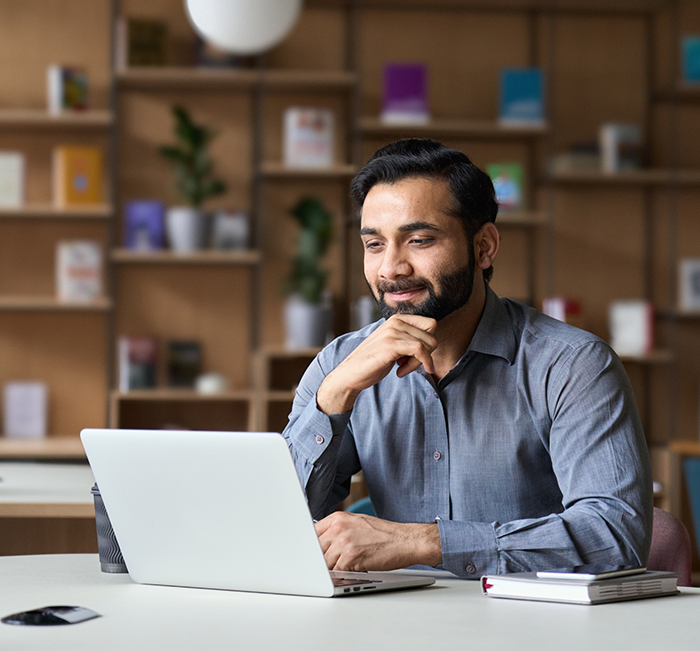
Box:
360, 178, 475, 321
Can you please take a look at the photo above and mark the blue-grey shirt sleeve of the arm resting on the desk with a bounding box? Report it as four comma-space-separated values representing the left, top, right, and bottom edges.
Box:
438, 342, 653, 578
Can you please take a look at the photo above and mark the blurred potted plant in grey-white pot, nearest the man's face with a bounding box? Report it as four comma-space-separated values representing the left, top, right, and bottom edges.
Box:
284, 197, 333, 349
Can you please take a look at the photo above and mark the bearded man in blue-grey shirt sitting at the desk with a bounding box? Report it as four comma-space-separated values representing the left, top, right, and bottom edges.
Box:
284, 139, 652, 577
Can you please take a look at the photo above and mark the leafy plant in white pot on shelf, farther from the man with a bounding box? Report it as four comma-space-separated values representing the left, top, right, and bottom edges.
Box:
159, 106, 226, 252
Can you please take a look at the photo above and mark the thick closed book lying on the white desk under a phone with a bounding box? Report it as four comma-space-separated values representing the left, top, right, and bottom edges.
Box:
481, 571, 678, 605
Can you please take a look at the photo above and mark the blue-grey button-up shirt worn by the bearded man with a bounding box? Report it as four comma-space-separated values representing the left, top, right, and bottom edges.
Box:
284, 289, 652, 577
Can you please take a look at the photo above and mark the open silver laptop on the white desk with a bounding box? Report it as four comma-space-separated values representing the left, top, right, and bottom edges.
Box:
80, 429, 435, 597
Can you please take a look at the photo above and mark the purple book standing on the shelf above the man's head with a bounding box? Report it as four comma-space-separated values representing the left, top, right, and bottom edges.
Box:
381, 63, 430, 124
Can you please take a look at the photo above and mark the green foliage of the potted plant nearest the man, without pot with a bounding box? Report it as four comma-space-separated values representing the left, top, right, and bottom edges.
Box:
284, 197, 333, 303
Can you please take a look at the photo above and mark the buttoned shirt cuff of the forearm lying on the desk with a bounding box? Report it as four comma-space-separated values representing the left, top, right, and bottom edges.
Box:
437, 519, 498, 579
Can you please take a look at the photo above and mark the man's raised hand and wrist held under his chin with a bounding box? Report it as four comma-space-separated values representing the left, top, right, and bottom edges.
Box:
316, 314, 437, 415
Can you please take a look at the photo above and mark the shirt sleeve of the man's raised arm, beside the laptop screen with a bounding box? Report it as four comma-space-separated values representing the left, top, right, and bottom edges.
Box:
282, 352, 361, 520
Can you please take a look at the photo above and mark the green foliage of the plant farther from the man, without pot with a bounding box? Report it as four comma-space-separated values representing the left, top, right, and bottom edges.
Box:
158, 106, 226, 208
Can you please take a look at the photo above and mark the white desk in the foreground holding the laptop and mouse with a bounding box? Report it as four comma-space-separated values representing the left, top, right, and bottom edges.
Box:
0, 554, 700, 651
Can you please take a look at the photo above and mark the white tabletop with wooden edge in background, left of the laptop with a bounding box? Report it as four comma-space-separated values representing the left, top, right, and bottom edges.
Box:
0, 462, 95, 518
